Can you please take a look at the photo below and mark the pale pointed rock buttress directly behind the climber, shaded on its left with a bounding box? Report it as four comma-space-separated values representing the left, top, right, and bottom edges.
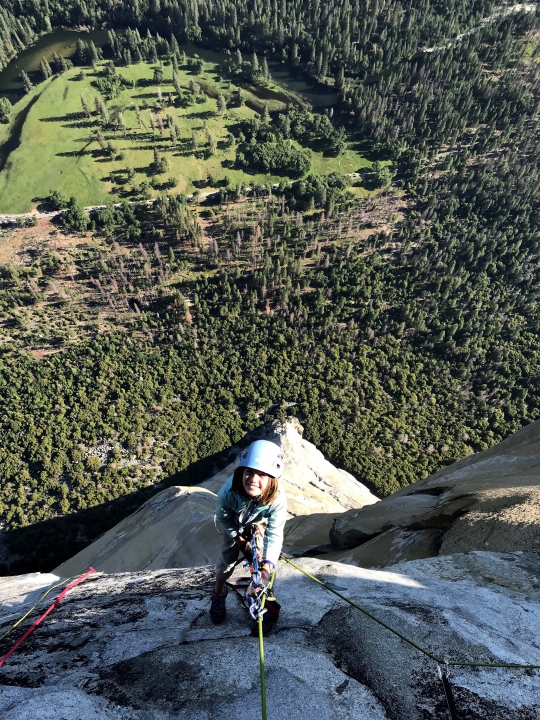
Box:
55, 420, 377, 576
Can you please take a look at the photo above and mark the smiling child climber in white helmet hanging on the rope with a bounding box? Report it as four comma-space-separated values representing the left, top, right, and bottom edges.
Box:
210, 440, 287, 629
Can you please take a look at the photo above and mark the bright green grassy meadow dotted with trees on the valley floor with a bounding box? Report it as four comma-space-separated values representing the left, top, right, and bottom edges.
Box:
0, 47, 371, 213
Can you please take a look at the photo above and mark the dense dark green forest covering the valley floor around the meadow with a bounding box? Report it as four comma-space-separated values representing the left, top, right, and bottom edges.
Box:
0, 0, 540, 572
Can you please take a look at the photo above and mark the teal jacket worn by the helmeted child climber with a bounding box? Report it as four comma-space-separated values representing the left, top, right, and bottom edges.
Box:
216, 475, 287, 567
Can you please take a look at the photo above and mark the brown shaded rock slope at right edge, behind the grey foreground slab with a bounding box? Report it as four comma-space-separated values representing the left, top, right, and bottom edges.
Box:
329, 422, 540, 567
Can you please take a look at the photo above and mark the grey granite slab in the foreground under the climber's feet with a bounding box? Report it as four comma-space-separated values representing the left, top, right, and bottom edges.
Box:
0, 552, 540, 720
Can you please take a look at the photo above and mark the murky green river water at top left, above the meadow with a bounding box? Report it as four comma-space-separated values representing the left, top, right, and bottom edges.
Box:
0, 29, 107, 96
